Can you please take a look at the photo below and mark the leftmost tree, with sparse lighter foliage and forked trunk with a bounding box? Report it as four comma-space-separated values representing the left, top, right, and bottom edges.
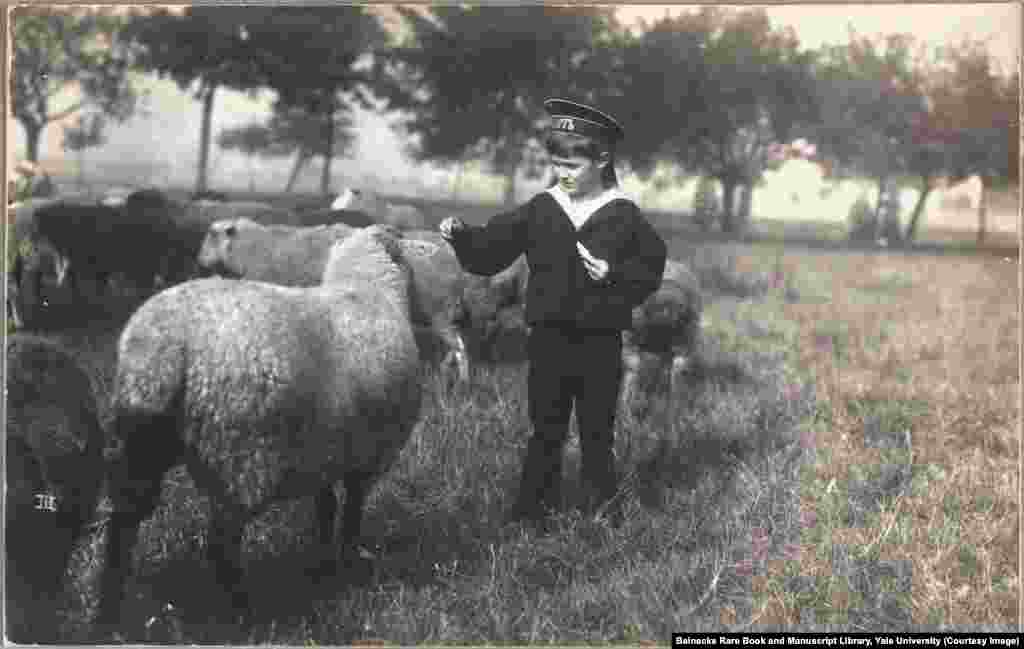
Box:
10, 6, 140, 163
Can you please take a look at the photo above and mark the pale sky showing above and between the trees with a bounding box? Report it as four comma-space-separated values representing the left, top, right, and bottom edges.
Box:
8, 3, 1021, 204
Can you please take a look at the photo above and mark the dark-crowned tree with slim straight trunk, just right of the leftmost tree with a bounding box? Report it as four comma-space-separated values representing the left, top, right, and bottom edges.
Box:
125, 5, 265, 191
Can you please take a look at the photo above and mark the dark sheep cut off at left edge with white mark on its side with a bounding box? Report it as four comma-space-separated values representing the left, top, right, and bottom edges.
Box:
4, 334, 104, 643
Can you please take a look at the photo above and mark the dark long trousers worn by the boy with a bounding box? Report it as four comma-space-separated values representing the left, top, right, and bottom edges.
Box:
516, 326, 623, 519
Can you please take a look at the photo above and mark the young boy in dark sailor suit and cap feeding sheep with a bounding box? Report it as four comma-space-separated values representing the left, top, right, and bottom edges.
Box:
440, 99, 666, 521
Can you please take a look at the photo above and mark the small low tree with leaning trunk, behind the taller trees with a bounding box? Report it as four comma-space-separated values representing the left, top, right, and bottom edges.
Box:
219, 105, 355, 192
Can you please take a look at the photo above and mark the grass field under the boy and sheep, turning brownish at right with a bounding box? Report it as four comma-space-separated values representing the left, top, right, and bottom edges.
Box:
6, 189, 1020, 645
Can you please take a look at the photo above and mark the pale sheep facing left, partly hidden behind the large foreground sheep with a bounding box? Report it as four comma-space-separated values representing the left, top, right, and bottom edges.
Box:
199, 219, 469, 380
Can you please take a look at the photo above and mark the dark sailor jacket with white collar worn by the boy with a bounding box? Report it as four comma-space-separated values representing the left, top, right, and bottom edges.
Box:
452, 187, 667, 331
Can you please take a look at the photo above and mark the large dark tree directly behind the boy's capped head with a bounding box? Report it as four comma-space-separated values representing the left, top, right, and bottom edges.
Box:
377, 5, 615, 203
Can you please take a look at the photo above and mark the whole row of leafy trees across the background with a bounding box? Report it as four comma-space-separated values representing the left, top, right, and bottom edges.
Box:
12, 5, 1018, 236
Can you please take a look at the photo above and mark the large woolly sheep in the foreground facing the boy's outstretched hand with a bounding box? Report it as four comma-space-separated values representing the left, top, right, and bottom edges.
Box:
97, 226, 422, 635
